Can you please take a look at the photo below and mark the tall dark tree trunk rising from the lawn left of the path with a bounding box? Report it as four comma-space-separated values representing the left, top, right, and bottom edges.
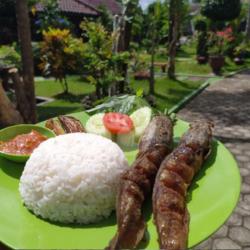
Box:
168, 0, 182, 79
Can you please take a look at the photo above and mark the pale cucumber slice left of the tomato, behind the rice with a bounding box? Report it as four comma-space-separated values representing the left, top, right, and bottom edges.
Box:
86, 113, 111, 139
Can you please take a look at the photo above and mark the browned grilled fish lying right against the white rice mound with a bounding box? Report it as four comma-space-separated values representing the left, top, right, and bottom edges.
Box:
107, 116, 173, 249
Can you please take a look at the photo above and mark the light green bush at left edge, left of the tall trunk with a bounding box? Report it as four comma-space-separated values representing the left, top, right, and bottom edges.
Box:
0, 45, 21, 68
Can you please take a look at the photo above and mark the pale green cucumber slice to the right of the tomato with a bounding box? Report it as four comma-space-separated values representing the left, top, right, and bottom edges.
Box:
130, 107, 152, 141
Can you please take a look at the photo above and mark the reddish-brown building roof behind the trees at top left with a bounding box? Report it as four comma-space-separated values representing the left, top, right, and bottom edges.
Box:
36, 0, 121, 16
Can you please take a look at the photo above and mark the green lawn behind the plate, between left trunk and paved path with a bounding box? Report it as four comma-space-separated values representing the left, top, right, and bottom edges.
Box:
36, 76, 202, 121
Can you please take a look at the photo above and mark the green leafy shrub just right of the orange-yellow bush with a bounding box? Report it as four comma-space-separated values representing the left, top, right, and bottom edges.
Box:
80, 21, 129, 98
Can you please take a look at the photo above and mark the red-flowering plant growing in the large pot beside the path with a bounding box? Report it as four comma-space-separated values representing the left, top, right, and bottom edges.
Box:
208, 26, 235, 55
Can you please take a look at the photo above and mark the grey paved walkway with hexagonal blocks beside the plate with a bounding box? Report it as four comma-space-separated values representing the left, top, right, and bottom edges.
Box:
178, 70, 250, 250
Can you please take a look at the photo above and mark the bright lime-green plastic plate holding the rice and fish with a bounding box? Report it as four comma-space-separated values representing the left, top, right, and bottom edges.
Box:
0, 112, 241, 249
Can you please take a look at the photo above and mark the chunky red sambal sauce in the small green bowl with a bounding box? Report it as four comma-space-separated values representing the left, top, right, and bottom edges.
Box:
0, 130, 48, 155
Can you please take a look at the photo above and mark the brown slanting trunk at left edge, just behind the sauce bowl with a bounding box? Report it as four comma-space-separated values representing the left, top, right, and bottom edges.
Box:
0, 82, 23, 128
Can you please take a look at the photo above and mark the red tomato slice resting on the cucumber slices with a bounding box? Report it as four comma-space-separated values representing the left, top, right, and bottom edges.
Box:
103, 112, 134, 134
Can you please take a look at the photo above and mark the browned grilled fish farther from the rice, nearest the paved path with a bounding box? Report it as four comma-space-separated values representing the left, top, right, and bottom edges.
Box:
153, 122, 212, 250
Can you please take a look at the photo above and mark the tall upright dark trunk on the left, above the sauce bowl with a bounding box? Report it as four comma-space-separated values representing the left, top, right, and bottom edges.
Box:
16, 0, 37, 123
